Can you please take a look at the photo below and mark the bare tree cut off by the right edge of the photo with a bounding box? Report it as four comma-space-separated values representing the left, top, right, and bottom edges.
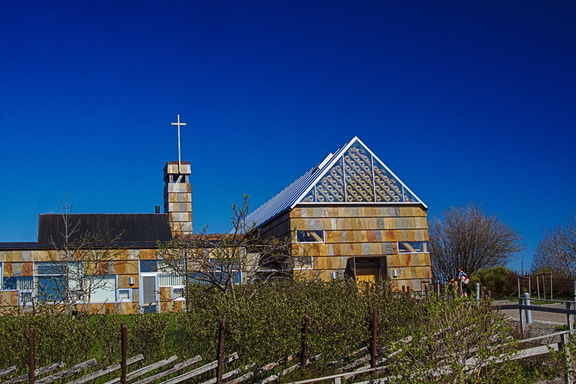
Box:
532, 215, 576, 276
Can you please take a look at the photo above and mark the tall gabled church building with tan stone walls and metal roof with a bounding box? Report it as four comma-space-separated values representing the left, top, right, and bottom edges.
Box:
246, 137, 432, 291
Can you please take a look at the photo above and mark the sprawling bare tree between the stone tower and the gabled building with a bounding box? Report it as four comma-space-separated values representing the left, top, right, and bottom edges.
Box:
159, 196, 294, 301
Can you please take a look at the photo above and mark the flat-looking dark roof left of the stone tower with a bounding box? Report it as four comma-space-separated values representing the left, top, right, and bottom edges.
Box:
38, 213, 172, 243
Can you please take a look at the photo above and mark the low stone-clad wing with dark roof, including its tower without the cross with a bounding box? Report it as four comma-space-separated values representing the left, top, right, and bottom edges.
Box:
0, 162, 192, 313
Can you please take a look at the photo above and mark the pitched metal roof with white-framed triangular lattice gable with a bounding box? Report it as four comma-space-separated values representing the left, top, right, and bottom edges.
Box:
246, 137, 427, 227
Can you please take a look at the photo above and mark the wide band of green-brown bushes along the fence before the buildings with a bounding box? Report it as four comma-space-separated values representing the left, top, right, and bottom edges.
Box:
0, 281, 568, 383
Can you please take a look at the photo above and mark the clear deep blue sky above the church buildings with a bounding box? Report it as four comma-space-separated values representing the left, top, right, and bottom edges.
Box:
0, 0, 576, 269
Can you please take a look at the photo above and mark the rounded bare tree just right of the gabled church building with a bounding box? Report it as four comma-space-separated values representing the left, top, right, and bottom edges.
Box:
429, 204, 523, 278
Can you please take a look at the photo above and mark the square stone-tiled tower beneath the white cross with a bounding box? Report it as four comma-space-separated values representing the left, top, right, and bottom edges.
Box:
164, 161, 192, 235
